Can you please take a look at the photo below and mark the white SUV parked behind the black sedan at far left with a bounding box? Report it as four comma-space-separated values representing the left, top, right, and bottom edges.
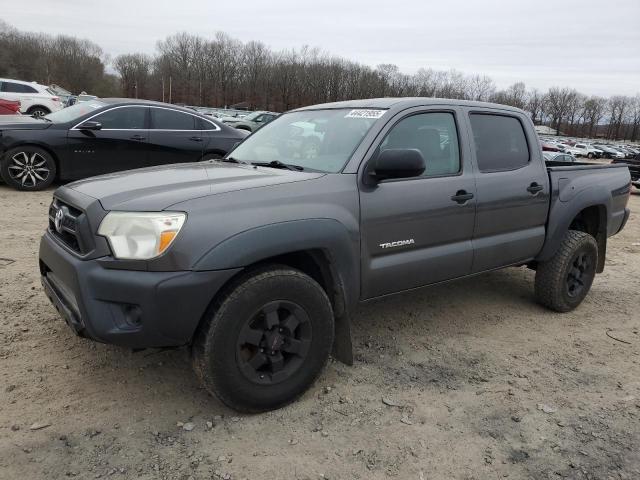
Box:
0, 78, 64, 117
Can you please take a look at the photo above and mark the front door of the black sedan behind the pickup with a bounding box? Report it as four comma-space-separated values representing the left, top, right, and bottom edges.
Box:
68, 105, 149, 178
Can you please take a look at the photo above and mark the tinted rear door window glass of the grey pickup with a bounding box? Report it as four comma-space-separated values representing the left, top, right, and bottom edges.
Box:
471, 113, 529, 172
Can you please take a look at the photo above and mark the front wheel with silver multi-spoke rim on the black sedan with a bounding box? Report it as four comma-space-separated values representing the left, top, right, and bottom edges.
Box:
0, 145, 57, 191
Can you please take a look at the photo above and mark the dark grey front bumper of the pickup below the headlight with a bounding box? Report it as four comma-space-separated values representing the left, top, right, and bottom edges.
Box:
40, 232, 239, 348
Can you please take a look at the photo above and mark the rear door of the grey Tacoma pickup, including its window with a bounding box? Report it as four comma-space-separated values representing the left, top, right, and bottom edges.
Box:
467, 109, 549, 273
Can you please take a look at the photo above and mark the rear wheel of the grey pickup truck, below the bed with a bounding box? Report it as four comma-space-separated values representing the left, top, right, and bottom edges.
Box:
535, 230, 598, 312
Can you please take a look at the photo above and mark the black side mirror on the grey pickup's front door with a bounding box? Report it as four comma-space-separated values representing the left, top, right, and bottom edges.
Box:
365, 148, 426, 185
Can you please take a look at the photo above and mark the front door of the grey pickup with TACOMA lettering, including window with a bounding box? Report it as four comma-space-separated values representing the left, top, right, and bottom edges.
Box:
360, 109, 476, 299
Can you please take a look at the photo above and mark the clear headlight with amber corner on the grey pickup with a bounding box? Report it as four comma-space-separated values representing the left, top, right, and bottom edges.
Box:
98, 212, 187, 260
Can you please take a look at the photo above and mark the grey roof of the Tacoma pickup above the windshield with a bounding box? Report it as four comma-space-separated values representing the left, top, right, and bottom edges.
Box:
294, 97, 523, 113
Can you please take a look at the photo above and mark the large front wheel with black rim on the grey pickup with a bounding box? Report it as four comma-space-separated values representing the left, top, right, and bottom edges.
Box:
191, 265, 334, 413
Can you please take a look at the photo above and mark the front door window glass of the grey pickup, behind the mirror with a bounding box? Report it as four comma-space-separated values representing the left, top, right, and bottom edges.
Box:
380, 112, 460, 177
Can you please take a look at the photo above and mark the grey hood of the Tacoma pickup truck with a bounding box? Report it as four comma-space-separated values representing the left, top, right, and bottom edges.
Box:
67, 161, 324, 211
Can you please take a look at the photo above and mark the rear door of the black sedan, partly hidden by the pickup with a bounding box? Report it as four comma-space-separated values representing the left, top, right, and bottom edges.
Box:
149, 107, 206, 165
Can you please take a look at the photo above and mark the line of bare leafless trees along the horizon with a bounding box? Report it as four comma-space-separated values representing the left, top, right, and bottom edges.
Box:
0, 22, 640, 141
